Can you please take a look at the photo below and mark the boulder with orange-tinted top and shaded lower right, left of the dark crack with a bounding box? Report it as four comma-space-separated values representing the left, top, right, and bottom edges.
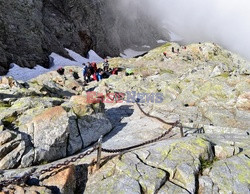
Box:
23, 106, 69, 163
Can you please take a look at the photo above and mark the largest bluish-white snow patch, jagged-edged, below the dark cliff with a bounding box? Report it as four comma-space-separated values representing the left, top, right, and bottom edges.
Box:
0, 49, 103, 81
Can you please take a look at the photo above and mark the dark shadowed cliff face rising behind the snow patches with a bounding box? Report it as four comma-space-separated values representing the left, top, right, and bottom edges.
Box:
0, 0, 166, 74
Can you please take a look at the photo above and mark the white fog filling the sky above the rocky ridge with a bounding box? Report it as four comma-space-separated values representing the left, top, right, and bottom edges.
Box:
116, 0, 250, 60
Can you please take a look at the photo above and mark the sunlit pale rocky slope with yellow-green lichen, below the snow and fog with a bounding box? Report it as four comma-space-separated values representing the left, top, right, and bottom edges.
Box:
0, 43, 250, 194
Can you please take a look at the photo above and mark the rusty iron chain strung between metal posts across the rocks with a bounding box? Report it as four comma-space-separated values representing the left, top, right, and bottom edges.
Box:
0, 103, 182, 191
